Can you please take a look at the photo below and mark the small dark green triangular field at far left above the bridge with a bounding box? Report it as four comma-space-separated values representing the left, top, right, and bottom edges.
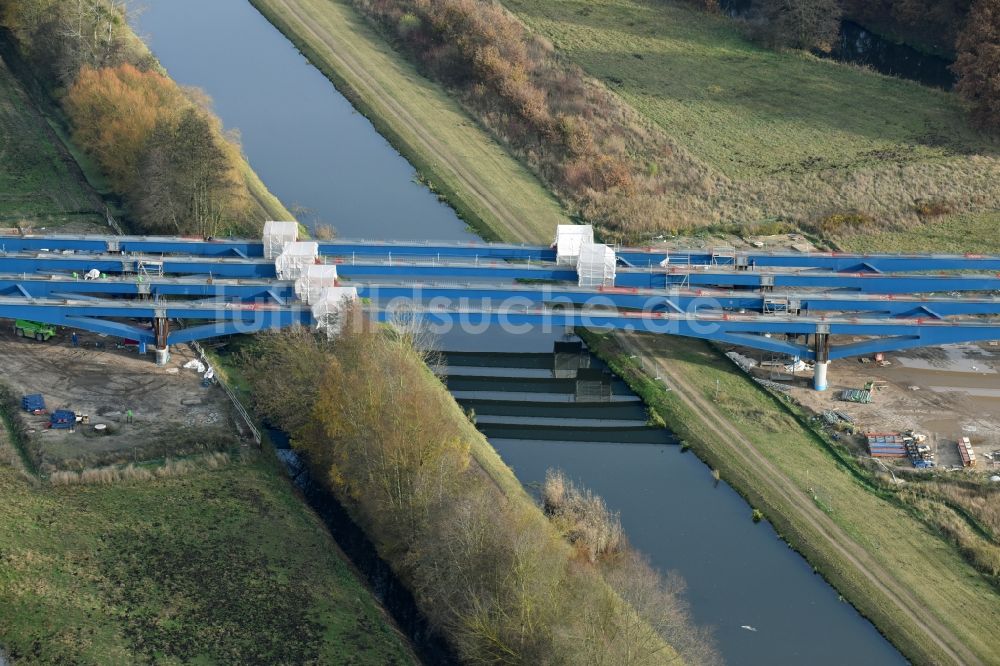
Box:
0, 55, 104, 229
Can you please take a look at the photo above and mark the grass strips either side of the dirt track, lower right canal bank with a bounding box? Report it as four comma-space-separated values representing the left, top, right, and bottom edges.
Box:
588, 336, 1000, 663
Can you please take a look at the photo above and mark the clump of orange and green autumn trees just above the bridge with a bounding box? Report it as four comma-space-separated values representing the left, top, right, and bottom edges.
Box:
63, 64, 251, 236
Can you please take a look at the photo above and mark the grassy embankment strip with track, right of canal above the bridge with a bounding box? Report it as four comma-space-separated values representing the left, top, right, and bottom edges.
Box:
251, 0, 569, 242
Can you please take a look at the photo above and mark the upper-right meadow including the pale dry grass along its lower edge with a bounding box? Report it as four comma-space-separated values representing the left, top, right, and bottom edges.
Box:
503, 0, 1000, 236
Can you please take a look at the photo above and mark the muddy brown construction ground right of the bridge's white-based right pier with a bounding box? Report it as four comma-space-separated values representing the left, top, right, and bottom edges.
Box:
780, 343, 1000, 473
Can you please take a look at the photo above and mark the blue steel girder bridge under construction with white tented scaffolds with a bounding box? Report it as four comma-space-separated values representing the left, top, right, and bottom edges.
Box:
0, 222, 1000, 390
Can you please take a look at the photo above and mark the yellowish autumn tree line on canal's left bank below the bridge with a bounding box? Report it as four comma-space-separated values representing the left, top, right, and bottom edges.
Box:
242, 312, 717, 665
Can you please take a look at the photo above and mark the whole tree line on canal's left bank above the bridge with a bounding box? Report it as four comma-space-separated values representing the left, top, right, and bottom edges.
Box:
0, 0, 262, 236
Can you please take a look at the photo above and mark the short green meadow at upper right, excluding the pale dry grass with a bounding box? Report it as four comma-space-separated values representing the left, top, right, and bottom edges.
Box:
504, 0, 997, 178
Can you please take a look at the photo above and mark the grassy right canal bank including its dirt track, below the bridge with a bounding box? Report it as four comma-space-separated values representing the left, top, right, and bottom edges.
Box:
584, 334, 1000, 663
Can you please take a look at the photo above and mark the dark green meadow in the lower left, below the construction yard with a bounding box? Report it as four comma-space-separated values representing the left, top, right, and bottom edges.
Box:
0, 430, 416, 665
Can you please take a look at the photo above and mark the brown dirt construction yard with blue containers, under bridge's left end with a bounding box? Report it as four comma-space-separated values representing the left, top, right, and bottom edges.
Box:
0, 320, 236, 472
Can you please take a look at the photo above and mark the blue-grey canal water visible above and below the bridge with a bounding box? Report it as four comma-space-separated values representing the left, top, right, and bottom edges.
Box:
138, 0, 903, 666
